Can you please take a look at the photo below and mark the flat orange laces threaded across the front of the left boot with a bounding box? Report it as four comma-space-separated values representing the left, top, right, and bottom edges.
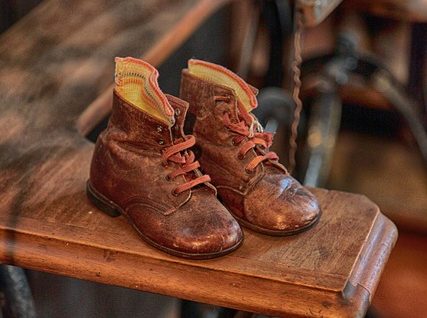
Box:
162, 135, 211, 195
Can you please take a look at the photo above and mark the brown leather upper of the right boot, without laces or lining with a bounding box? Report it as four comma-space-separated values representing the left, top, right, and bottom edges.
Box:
180, 70, 320, 232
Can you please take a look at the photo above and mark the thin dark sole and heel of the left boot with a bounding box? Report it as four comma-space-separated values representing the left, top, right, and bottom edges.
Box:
86, 180, 243, 260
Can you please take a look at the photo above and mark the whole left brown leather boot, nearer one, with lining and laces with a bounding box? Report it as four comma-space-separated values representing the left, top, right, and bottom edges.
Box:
87, 58, 242, 259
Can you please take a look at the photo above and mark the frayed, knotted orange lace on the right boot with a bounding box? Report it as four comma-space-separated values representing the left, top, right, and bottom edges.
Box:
215, 96, 287, 173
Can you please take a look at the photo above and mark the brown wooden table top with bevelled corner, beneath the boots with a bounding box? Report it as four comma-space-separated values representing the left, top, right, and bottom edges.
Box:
0, 0, 397, 317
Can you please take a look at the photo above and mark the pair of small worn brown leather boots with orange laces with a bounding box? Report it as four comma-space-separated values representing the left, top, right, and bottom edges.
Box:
87, 58, 320, 259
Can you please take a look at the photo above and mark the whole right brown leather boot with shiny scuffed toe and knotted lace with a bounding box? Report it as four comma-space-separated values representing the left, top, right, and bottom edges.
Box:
180, 60, 320, 235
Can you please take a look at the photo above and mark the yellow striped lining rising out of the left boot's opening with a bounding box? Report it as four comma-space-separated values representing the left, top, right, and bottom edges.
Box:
115, 57, 174, 126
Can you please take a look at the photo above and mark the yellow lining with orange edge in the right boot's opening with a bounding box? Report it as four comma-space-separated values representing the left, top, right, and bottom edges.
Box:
188, 59, 258, 121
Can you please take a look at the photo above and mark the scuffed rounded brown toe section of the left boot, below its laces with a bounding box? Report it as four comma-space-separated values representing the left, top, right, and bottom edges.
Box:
127, 190, 243, 259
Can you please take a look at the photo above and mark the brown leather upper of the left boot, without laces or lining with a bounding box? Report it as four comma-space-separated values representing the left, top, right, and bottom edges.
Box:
90, 92, 242, 254
